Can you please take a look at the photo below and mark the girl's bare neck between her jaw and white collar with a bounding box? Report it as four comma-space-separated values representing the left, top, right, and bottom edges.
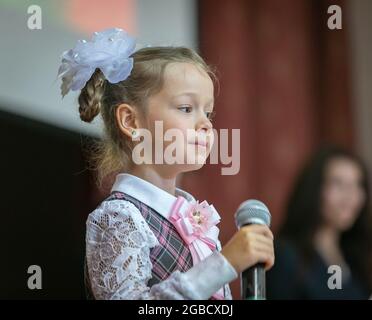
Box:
128, 165, 176, 195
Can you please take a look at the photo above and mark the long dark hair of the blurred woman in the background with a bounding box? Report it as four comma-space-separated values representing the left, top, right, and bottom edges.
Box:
279, 147, 372, 291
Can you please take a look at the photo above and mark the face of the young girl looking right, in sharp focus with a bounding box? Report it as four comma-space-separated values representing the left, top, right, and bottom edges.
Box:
144, 62, 214, 174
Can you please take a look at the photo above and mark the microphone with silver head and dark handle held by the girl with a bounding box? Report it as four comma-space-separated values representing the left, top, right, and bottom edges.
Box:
235, 200, 271, 300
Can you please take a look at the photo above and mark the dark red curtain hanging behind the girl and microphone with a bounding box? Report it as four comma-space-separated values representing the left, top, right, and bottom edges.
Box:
182, 0, 354, 299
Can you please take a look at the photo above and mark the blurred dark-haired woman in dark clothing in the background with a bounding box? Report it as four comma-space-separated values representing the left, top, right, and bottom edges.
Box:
267, 147, 372, 299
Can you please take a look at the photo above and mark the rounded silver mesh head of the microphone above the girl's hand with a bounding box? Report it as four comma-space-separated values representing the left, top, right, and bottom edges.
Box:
235, 199, 271, 229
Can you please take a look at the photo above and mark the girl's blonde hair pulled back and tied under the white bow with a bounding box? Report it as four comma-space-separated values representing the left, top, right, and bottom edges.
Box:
78, 47, 217, 187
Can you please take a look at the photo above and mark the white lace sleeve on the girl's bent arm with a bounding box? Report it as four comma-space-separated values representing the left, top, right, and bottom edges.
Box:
86, 200, 235, 300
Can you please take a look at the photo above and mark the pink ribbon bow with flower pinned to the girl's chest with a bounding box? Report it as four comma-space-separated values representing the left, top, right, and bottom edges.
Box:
169, 196, 224, 300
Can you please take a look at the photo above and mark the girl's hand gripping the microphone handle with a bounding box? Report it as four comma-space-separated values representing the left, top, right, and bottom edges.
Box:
221, 224, 275, 273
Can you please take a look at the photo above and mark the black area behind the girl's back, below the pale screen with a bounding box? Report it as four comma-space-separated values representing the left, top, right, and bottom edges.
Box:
0, 112, 97, 299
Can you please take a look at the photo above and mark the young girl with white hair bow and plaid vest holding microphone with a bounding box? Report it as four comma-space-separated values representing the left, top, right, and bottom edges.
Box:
59, 29, 274, 299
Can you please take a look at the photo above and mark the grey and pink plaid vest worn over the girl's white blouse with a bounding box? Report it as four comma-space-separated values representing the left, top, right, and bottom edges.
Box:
84, 191, 224, 300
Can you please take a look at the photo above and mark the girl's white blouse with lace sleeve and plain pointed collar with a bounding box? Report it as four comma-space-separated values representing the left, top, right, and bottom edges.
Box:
86, 174, 238, 300
